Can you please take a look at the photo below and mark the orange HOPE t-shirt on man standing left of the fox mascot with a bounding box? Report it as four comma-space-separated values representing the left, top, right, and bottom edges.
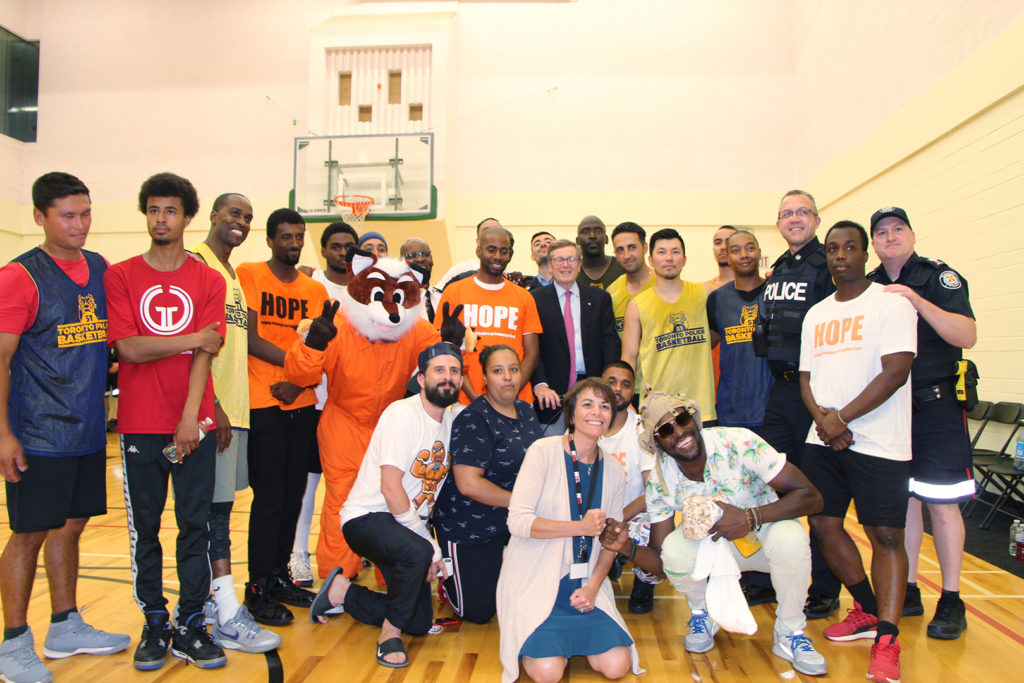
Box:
236, 262, 328, 411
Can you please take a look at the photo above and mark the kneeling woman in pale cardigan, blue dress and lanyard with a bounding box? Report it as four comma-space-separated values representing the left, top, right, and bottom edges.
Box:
498, 378, 642, 683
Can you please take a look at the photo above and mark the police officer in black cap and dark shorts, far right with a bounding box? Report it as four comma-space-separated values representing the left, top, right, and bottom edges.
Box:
867, 207, 977, 640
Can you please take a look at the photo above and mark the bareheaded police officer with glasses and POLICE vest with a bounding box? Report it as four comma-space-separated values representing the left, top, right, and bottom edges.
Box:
742, 189, 841, 618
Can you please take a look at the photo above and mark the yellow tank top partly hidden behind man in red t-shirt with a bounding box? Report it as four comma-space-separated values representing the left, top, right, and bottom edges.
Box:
193, 243, 249, 429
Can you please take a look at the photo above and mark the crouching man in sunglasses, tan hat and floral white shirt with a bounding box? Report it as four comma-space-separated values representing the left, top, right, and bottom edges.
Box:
601, 391, 828, 676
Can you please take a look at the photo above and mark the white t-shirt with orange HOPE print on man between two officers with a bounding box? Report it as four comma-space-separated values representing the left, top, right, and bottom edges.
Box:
800, 283, 918, 461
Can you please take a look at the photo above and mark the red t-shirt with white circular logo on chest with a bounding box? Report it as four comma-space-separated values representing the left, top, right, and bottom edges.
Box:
103, 256, 226, 434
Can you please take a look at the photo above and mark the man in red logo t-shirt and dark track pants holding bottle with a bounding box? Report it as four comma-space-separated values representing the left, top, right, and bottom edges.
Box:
104, 173, 226, 671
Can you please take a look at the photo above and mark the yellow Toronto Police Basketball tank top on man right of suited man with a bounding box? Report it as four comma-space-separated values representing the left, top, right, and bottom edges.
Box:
635, 279, 717, 420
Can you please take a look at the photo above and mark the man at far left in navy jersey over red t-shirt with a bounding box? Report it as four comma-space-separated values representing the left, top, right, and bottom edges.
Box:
0, 172, 131, 681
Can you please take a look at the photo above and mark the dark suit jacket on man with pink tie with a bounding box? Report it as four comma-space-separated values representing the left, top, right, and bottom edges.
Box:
530, 283, 623, 422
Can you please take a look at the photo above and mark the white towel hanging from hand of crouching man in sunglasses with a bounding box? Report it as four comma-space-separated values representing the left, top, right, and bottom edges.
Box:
691, 535, 758, 635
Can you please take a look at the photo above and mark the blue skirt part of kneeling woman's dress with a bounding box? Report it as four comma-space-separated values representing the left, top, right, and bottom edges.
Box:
519, 574, 633, 658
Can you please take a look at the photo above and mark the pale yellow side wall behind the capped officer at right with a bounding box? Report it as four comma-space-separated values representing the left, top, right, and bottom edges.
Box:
808, 22, 1024, 409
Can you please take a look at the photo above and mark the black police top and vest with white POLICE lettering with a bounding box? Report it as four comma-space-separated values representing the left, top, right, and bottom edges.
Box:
762, 238, 836, 375
